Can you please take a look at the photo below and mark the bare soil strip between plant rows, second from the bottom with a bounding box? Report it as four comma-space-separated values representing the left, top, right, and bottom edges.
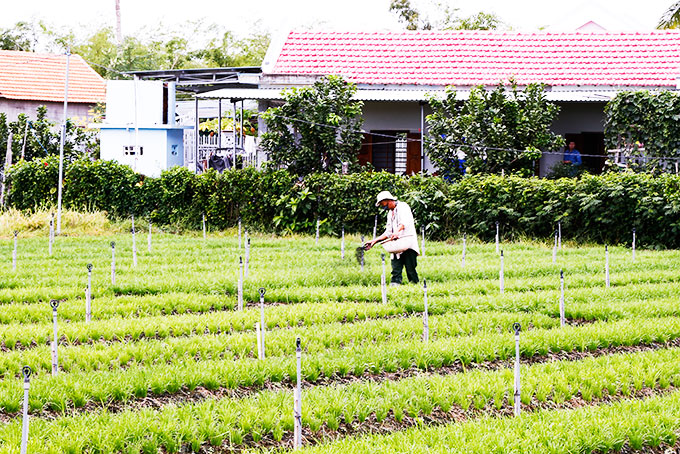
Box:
0, 338, 680, 423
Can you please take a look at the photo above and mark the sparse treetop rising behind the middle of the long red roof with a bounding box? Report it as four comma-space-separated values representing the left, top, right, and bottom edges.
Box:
390, 0, 503, 30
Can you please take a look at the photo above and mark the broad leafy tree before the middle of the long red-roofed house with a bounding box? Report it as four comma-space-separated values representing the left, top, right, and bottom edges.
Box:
425, 81, 564, 178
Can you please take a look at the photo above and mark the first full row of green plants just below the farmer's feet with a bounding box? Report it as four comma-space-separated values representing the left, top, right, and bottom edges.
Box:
5, 258, 678, 329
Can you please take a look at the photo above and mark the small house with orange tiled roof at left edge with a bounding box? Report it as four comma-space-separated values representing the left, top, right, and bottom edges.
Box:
0, 50, 106, 124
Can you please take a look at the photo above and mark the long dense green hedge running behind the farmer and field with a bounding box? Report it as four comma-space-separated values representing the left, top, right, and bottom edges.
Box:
8, 158, 680, 248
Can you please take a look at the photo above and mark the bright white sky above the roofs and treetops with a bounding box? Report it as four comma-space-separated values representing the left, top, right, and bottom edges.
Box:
0, 0, 674, 39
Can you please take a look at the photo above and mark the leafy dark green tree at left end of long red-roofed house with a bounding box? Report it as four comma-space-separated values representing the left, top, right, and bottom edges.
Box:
261, 76, 363, 175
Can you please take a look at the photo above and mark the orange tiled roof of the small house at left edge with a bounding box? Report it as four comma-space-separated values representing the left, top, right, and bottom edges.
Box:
0, 50, 106, 103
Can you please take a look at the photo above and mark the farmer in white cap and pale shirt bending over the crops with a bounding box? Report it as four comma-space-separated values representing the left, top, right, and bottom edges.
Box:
366, 191, 420, 286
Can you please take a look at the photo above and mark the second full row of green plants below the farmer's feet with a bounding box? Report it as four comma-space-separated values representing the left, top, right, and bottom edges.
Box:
6, 284, 680, 354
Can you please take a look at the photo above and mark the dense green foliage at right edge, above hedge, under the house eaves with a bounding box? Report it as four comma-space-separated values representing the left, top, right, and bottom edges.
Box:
604, 90, 680, 170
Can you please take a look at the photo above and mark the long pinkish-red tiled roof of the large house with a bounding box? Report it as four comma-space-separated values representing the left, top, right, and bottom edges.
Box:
265, 30, 680, 86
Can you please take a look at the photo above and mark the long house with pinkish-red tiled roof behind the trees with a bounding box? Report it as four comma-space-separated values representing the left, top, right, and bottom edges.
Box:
205, 30, 680, 174
